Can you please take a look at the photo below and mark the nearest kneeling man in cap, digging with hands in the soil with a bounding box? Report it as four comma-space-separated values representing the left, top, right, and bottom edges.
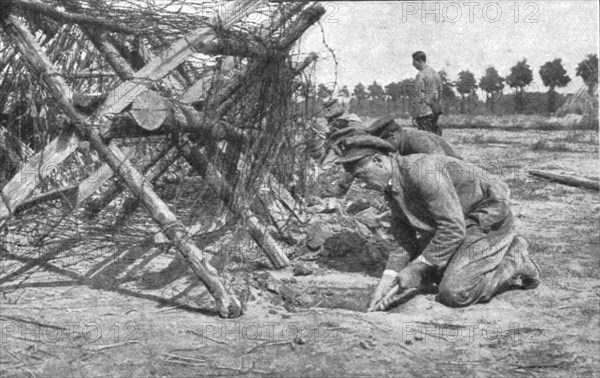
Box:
339, 137, 539, 311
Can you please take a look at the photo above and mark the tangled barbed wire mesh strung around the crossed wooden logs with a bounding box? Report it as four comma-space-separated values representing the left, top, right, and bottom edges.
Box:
0, 0, 338, 292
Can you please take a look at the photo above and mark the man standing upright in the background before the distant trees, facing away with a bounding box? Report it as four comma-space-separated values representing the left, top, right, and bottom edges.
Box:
412, 51, 442, 136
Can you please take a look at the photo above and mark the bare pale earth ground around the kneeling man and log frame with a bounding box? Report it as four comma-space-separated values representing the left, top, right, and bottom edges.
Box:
0, 124, 600, 377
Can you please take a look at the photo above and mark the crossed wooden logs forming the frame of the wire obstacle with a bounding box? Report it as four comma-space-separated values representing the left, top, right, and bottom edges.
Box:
0, 0, 324, 318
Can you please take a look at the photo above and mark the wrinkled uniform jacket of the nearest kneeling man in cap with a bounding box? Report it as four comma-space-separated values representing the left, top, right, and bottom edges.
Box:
385, 154, 512, 269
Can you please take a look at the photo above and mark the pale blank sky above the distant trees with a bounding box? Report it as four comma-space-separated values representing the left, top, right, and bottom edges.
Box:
300, 0, 598, 92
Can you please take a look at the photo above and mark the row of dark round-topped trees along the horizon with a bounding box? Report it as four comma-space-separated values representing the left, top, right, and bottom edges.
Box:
313, 54, 598, 115
